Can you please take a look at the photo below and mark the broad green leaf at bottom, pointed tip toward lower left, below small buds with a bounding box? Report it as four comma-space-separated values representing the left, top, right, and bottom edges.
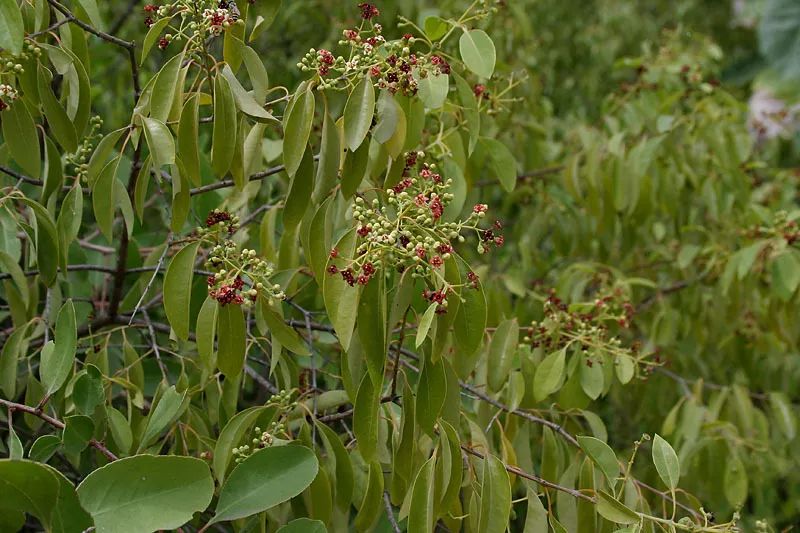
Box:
209, 445, 319, 524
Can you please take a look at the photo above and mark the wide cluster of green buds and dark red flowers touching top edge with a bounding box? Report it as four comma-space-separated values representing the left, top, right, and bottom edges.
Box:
297, 3, 450, 96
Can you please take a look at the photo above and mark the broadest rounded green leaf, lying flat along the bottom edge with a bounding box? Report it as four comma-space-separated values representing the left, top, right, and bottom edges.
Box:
78, 455, 214, 533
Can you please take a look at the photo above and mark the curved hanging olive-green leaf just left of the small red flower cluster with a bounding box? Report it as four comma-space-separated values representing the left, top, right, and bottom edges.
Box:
164, 242, 200, 340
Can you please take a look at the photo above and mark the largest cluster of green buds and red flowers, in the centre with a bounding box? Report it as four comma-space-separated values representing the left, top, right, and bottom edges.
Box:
328, 152, 502, 312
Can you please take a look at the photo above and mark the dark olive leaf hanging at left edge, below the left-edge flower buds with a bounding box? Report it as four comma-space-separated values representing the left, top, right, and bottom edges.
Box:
0, 97, 42, 179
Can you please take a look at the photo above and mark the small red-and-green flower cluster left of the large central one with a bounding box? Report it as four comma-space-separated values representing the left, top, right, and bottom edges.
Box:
197, 210, 286, 306
